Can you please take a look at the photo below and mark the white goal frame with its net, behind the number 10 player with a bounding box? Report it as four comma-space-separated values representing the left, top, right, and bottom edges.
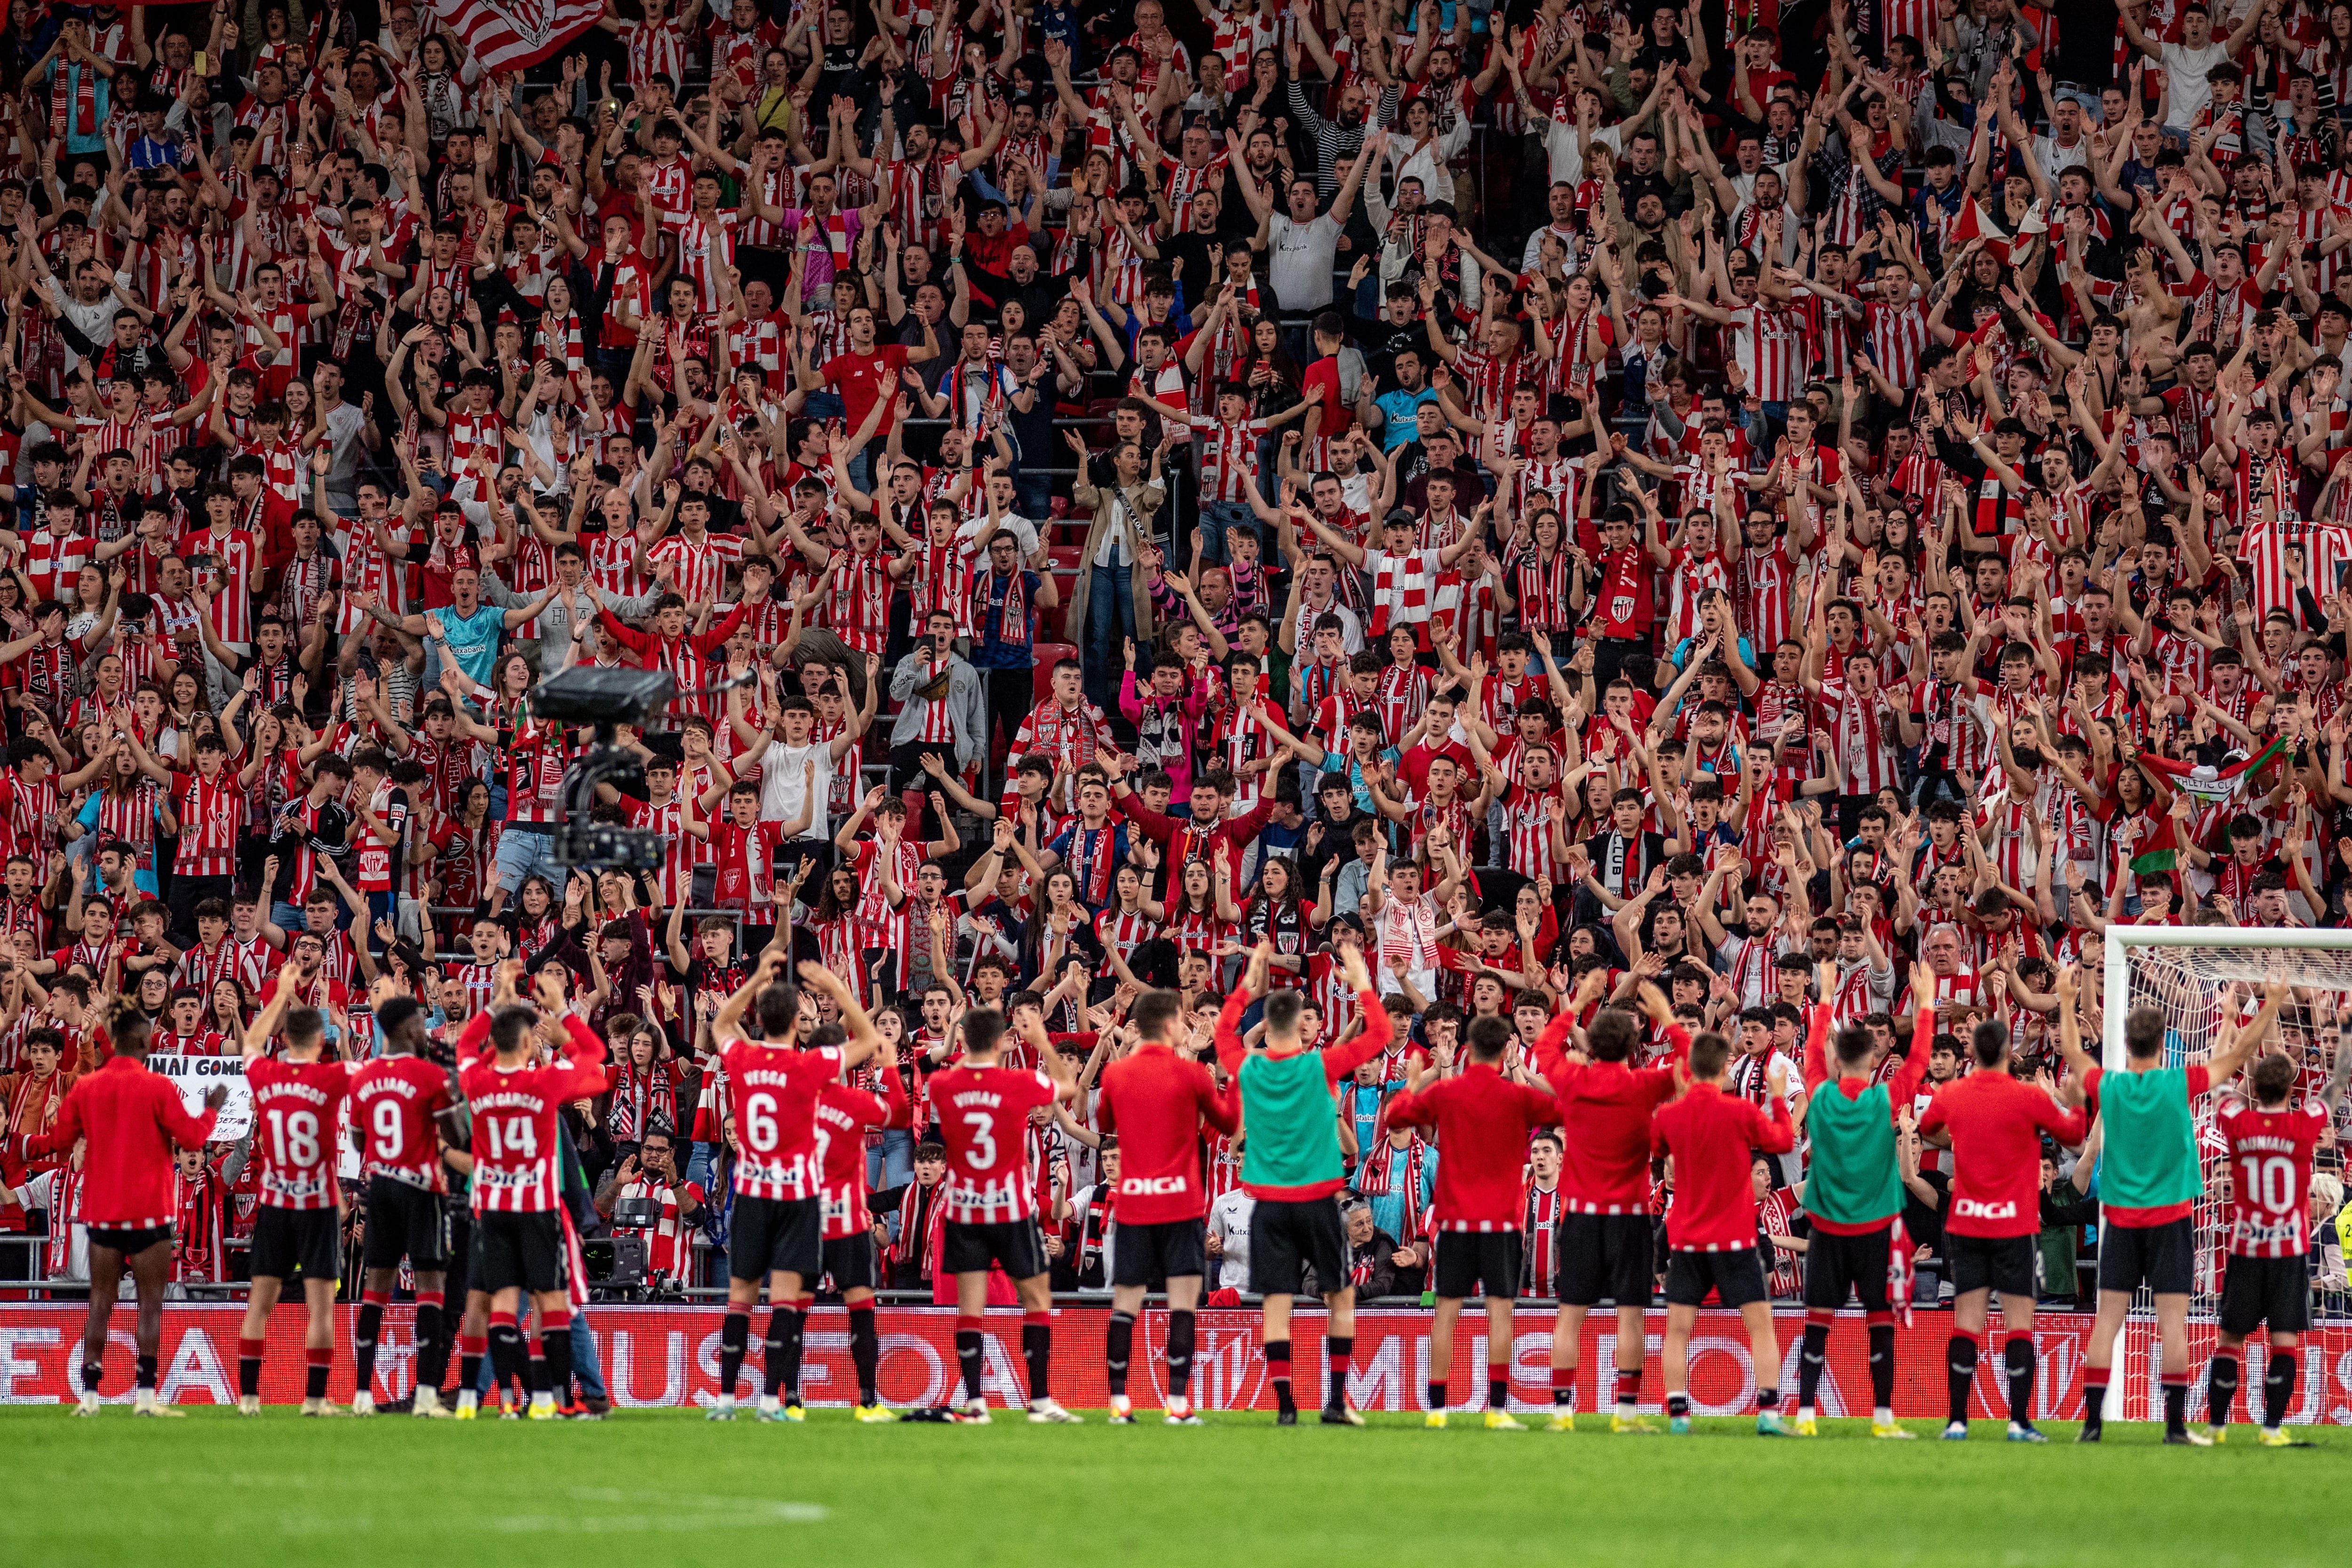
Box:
2098, 926, 2352, 1420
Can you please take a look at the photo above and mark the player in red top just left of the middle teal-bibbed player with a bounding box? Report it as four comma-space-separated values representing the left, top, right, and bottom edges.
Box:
1649, 1029, 1797, 1436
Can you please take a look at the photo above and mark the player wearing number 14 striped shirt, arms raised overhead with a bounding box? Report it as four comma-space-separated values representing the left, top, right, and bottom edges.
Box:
456, 959, 604, 1420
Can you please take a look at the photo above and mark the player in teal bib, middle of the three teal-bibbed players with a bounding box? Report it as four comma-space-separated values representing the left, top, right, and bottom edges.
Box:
1797, 964, 1936, 1439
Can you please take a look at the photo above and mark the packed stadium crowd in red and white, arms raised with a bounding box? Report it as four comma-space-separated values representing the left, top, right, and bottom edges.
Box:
0, 0, 2352, 1439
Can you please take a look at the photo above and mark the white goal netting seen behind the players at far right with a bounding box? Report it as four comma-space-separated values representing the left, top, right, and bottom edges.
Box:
2098, 926, 2352, 1316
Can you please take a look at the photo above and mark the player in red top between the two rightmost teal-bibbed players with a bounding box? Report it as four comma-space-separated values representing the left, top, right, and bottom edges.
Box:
1919, 1011, 2086, 1443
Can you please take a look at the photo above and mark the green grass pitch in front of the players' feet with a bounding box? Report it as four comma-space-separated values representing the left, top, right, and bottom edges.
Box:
0, 1406, 2352, 1568
